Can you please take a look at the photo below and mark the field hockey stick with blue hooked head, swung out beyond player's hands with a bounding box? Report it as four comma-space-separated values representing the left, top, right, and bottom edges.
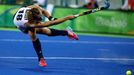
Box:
74, 0, 110, 17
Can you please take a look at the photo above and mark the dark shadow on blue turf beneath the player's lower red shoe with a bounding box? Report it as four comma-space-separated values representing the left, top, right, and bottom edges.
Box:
18, 67, 85, 75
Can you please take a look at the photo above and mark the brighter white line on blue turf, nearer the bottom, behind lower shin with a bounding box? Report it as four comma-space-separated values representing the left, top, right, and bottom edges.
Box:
0, 57, 134, 61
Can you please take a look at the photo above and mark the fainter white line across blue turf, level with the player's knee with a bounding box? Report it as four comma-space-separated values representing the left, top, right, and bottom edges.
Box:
0, 39, 134, 45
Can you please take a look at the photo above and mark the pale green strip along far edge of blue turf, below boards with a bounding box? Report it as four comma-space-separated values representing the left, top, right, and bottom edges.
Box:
0, 28, 134, 39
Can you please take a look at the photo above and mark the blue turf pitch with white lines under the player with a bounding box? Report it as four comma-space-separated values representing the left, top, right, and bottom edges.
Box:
0, 30, 134, 75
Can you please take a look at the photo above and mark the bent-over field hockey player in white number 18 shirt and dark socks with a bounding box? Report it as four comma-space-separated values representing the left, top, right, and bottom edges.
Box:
13, 4, 78, 67
